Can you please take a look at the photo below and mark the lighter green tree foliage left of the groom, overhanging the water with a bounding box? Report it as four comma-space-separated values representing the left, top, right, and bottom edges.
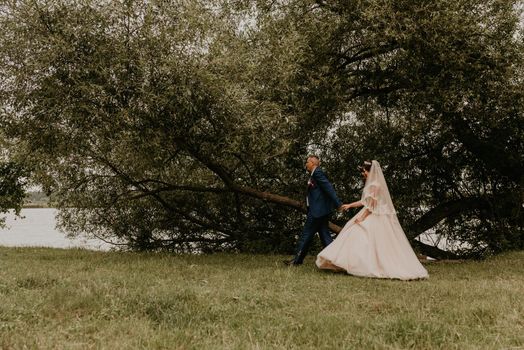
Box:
2, 2, 301, 251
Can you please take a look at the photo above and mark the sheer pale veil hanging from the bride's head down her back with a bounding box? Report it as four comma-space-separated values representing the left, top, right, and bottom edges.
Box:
360, 160, 396, 216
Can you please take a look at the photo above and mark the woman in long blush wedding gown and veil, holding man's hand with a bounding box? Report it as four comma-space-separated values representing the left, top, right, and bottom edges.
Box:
316, 160, 428, 280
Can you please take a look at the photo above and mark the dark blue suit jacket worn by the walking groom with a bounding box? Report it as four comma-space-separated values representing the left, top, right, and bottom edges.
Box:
307, 167, 342, 218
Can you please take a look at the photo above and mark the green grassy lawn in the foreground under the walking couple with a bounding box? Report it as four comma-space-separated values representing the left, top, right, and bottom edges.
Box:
0, 248, 524, 350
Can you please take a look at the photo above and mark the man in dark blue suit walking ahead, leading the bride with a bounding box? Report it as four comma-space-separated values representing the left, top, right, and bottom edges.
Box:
284, 155, 343, 265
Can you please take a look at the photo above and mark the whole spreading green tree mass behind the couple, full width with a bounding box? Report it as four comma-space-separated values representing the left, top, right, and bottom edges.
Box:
0, 0, 523, 256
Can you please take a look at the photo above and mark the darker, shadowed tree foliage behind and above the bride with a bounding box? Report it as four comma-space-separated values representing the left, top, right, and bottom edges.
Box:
294, 1, 524, 256
